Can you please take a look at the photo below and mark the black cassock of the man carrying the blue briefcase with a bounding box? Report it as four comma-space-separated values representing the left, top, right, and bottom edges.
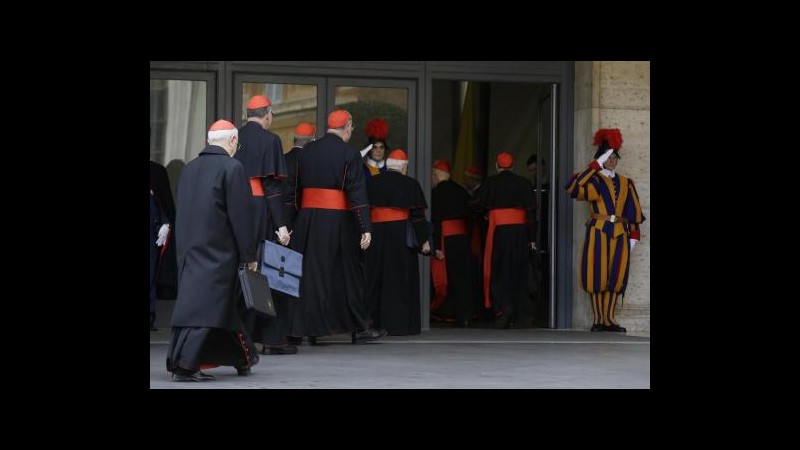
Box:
233, 122, 290, 344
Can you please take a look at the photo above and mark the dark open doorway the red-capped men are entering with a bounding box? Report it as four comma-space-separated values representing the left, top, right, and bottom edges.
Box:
428, 80, 557, 328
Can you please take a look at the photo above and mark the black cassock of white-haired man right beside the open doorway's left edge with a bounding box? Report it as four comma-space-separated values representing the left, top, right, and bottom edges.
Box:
364, 169, 428, 336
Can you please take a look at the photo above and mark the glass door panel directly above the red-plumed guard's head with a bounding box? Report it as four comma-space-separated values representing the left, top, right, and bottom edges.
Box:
334, 86, 409, 156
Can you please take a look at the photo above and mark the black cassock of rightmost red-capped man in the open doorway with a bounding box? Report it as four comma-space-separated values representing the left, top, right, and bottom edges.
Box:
476, 171, 536, 316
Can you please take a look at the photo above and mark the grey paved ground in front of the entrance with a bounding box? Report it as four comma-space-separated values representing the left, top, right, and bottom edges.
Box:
150, 328, 650, 389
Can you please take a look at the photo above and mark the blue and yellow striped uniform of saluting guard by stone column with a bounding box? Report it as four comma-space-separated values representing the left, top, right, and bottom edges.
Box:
566, 161, 645, 325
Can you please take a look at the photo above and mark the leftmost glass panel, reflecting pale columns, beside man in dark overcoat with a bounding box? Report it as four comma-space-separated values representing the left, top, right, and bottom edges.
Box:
150, 79, 210, 197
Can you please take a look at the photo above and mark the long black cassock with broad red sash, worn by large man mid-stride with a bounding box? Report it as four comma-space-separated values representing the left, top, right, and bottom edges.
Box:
289, 134, 372, 336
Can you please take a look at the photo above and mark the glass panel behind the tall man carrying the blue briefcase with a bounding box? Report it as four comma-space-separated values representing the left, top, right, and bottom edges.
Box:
241, 83, 318, 153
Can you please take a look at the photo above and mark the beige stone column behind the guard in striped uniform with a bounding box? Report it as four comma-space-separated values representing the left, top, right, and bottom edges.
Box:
562, 61, 653, 333
